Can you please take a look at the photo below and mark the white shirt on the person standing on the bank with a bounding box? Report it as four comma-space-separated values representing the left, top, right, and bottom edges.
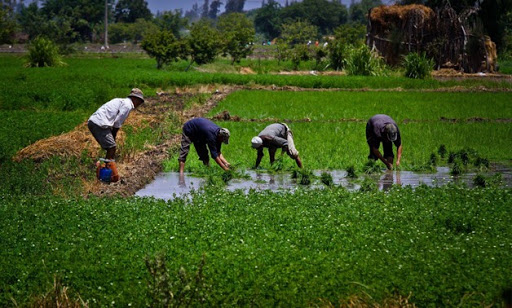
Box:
89, 97, 135, 128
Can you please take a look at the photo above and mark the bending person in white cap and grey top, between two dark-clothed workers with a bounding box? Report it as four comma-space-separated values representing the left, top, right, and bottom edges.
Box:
251, 123, 302, 168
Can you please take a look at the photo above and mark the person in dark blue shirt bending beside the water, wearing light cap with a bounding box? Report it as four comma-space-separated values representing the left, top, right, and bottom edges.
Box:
178, 118, 231, 177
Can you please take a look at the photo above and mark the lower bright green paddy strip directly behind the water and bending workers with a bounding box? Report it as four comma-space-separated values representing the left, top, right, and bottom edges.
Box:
166, 122, 512, 172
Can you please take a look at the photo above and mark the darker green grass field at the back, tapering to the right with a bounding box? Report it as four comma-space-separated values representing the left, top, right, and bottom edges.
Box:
0, 55, 512, 113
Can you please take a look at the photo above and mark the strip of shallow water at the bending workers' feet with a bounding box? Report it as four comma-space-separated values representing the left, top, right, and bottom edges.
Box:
136, 167, 512, 200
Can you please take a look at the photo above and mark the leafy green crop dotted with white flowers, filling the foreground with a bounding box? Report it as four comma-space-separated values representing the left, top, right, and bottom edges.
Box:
0, 186, 512, 307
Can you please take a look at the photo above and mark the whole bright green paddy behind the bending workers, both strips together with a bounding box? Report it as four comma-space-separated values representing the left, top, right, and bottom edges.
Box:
168, 91, 512, 171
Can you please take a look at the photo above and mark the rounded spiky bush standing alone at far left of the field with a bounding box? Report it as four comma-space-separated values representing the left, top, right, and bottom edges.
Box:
26, 37, 64, 67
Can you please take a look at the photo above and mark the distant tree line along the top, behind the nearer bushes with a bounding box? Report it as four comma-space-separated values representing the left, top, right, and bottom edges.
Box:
0, 0, 512, 56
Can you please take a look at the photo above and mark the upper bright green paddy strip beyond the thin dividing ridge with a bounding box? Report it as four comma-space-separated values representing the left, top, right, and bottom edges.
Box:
209, 91, 512, 122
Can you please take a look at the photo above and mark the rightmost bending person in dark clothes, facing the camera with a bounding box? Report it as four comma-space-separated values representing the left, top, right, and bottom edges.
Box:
366, 114, 402, 170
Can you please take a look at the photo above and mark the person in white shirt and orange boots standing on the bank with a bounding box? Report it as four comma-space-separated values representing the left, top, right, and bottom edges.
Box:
87, 88, 144, 182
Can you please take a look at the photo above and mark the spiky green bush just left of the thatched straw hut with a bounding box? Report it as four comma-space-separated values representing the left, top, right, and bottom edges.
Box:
344, 45, 385, 76
